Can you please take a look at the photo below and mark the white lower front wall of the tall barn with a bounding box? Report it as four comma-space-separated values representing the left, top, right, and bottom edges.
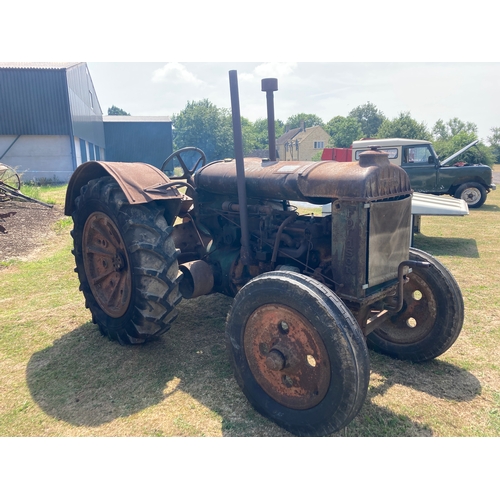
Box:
0, 135, 73, 182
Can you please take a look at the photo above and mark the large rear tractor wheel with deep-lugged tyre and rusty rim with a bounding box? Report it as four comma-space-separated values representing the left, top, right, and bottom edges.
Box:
71, 177, 182, 344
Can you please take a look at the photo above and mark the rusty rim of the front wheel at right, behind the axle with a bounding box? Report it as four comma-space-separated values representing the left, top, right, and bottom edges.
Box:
377, 272, 437, 344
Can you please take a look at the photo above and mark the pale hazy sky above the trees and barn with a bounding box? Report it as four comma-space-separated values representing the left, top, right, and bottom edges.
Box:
86, 61, 500, 143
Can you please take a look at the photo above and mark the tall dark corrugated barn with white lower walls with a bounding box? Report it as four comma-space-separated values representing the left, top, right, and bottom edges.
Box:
0, 62, 105, 182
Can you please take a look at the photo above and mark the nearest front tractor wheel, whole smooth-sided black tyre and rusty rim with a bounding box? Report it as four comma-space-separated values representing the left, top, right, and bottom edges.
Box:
226, 271, 370, 436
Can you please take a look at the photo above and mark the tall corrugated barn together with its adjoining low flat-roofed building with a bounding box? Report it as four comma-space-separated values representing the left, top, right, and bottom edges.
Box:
0, 62, 173, 183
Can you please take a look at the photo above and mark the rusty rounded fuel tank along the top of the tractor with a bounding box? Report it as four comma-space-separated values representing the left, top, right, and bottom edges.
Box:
194, 151, 412, 205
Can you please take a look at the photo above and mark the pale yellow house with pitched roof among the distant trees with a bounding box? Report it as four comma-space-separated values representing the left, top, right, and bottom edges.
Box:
276, 122, 330, 161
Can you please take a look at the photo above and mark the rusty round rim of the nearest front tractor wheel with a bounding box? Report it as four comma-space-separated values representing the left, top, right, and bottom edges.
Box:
243, 304, 330, 410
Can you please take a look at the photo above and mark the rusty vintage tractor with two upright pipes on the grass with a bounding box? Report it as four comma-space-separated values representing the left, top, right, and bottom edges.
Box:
65, 71, 464, 436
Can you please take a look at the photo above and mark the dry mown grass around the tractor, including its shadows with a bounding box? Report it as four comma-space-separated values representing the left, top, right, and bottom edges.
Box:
0, 178, 500, 437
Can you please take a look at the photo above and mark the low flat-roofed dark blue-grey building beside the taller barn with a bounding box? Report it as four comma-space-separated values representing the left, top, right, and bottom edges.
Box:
103, 115, 173, 174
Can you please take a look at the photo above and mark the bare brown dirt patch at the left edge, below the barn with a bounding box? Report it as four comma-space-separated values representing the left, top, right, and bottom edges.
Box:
0, 200, 64, 262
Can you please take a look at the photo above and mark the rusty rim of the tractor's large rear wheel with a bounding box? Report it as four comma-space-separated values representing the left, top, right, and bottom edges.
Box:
83, 212, 132, 318
